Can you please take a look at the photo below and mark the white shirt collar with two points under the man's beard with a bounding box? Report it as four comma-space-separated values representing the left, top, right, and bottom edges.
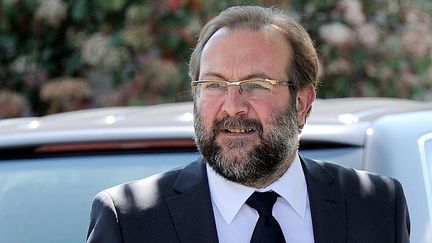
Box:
206, 155, 308, 225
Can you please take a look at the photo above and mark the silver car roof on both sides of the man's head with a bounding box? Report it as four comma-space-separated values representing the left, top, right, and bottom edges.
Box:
0, 98, 432, 148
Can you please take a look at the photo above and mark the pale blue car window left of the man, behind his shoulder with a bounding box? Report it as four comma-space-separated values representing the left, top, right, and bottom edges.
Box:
0, 152, 198, 243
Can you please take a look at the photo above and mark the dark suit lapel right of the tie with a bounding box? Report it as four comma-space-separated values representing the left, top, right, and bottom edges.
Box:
301, 158, 346, 243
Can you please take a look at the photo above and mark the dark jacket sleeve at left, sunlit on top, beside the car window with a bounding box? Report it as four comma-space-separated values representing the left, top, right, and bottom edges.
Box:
86, 191, 123, 243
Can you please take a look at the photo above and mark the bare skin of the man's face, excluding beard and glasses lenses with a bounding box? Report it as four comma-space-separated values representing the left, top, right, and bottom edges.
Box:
196, 27, 291, 149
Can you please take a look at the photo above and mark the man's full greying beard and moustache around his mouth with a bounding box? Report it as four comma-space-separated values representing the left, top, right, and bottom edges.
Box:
194, 105, 299, 186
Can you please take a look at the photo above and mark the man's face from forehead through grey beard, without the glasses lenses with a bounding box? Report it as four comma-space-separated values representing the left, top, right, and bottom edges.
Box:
194, 27, 299, 185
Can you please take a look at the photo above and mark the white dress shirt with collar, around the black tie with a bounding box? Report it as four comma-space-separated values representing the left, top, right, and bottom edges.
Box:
207, 155, 314, 243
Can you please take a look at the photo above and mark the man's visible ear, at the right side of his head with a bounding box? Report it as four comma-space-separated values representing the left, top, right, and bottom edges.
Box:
296, 85, 316, 127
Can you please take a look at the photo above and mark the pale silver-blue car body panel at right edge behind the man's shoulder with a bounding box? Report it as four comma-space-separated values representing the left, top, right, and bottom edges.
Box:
362, 111, 432, 242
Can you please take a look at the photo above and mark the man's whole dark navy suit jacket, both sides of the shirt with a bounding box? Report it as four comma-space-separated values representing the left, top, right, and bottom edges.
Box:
87, 158, 410, 243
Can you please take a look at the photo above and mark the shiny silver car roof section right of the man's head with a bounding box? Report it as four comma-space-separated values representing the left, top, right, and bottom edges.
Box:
301, 97, 432, 146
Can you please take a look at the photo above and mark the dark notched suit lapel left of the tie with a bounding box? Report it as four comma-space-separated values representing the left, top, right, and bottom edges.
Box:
167, 161, 218, 243
